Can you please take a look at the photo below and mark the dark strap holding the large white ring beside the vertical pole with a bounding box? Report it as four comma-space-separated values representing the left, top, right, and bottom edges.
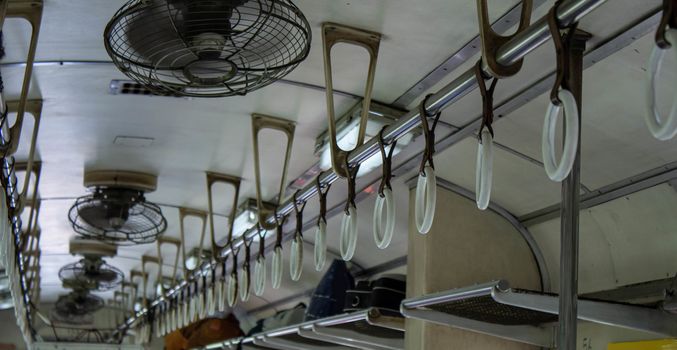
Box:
548, 0, 578, 106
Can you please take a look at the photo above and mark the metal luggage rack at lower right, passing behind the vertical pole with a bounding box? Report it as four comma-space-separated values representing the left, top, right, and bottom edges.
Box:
401, 280, 677, 347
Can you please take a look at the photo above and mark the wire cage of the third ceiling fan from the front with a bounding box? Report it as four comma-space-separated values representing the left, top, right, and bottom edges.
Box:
59, 259, 125, 292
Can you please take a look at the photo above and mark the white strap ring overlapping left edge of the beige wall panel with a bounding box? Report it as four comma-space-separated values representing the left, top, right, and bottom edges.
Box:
414, 166, 437, 234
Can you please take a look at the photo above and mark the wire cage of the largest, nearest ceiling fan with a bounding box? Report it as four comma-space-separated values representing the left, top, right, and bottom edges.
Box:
104, 0, 312, 97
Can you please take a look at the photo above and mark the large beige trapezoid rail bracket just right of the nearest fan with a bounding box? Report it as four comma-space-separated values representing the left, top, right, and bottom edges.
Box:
322, 23, 381, 178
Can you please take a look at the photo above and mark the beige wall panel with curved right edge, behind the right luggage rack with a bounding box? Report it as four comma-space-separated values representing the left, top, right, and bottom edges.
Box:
405, 188, 540, 350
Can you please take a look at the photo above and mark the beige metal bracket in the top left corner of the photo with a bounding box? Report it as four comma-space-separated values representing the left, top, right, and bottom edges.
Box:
0, 1, 43, 154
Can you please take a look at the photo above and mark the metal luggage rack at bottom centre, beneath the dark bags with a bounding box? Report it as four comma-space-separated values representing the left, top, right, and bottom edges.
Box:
198, 308, 404, 350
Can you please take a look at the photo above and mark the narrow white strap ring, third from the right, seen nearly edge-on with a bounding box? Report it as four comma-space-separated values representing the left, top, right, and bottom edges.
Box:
475, 130, 494, 210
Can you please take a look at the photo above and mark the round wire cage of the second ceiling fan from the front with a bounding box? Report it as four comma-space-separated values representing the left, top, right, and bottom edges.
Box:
68, 188, 167, 245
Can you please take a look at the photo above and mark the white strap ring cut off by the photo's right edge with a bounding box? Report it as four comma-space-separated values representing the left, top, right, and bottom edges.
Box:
645, 28, 677, 141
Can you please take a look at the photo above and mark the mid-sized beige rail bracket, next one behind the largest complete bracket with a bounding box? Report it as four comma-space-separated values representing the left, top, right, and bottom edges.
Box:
252, 113, 296, 230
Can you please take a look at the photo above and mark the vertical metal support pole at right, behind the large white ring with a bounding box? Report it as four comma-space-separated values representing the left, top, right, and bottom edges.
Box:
557, 30, 590, 350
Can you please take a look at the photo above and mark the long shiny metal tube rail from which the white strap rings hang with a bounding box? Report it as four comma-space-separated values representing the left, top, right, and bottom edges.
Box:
119, 0, 606, 329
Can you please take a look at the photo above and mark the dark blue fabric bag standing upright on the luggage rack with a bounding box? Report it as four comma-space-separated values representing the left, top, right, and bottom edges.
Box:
305, 260, 355, 321
